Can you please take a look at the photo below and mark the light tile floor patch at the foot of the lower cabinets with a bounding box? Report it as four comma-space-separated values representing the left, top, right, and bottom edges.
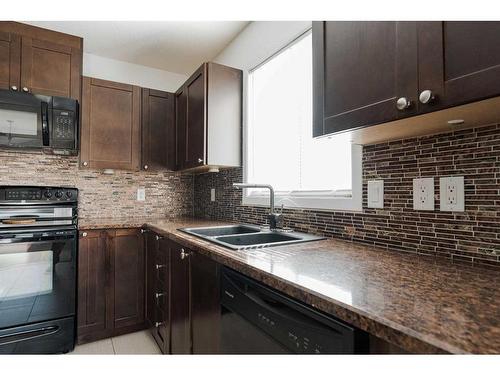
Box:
71, 331, 161, 354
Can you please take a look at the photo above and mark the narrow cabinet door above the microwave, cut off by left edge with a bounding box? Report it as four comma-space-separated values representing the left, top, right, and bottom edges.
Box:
0, 31, 21, 90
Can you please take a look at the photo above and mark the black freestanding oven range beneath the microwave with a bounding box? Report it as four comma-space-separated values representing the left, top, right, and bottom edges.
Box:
0, 186, 78, 354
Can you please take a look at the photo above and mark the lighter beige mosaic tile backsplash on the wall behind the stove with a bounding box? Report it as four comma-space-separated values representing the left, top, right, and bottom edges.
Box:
0, 150, 193, 218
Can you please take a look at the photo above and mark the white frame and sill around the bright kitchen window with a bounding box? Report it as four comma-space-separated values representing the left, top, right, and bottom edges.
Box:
242, 28, 363, 211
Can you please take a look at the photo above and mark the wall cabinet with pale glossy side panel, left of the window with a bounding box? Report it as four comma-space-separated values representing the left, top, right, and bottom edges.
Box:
175, 63, 242, 170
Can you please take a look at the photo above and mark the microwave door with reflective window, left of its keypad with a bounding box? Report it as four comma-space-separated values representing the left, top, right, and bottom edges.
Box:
0, 90, 49, 148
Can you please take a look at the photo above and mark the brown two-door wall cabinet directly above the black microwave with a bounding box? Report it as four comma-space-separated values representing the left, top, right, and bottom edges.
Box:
0, 22, 83, 100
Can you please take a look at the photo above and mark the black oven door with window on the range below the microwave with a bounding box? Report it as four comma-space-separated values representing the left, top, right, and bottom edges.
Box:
0, 229, 77, 329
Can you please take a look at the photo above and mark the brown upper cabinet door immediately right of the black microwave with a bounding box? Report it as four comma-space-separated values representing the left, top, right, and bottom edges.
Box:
80, 77, 141, 170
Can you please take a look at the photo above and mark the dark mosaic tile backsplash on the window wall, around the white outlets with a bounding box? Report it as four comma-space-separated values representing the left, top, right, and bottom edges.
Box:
194, 125, 500, 266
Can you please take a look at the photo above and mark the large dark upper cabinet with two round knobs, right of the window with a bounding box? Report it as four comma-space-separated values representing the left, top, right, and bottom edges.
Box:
312, 22, 500, 136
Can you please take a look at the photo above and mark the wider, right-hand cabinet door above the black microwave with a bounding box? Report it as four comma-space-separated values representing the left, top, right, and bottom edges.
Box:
21, 36, 82, 100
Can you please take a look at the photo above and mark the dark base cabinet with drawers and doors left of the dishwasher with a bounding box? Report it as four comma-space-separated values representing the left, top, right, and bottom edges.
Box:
145, 231, 220, 354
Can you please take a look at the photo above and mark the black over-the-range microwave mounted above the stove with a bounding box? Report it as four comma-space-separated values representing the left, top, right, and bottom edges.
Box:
0, 90, 78, 155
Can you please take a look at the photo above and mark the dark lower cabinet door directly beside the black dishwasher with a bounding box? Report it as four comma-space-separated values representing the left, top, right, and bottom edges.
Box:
190, 252, 220, 354
